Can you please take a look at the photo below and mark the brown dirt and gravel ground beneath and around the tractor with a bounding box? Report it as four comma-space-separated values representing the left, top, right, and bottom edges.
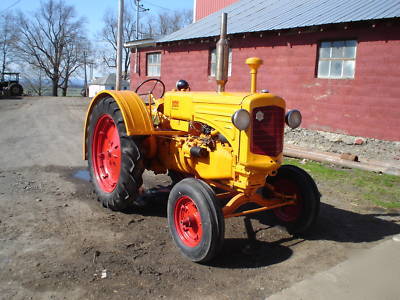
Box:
0, 97, 400, 299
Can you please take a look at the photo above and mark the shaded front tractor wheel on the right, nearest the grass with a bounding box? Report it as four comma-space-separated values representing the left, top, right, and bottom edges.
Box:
267, 165, 321, 235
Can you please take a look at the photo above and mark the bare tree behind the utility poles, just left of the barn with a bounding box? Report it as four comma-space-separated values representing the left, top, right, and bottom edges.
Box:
101, 9, 136, 80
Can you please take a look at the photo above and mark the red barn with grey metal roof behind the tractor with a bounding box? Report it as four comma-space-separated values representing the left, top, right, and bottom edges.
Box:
126, 0, 400, 141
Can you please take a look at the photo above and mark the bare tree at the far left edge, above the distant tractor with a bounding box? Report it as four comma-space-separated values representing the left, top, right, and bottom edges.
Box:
0, 14, 17, 77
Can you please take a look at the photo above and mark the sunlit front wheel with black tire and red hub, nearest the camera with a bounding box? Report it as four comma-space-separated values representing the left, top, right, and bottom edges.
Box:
168, 178, 225, 262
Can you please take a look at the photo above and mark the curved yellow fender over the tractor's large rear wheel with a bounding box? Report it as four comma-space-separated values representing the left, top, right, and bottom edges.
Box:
83, 90, 154, 160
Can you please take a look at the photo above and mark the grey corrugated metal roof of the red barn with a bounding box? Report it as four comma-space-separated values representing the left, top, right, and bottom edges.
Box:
157, 0, 400, 42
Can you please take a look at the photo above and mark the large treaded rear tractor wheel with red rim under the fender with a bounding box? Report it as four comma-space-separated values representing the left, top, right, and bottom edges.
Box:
87, 97, 144, 211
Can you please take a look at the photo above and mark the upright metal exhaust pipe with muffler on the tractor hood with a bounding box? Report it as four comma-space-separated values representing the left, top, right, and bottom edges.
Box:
215, 13, 229, 93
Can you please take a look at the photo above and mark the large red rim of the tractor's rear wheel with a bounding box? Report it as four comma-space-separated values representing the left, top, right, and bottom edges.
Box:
92, 114, 121, 193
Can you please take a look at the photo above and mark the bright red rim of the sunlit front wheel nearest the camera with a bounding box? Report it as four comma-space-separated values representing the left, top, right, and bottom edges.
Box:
174, 196, 203, 247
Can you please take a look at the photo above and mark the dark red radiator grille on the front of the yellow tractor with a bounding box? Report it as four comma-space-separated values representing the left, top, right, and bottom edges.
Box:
250, 106, 285, 156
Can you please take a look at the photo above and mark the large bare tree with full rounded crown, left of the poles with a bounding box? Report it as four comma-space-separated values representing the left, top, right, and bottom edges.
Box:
18, 0, 83, 96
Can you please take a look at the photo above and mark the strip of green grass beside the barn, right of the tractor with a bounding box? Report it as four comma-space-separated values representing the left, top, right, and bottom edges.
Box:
285, 158, 400, 209
